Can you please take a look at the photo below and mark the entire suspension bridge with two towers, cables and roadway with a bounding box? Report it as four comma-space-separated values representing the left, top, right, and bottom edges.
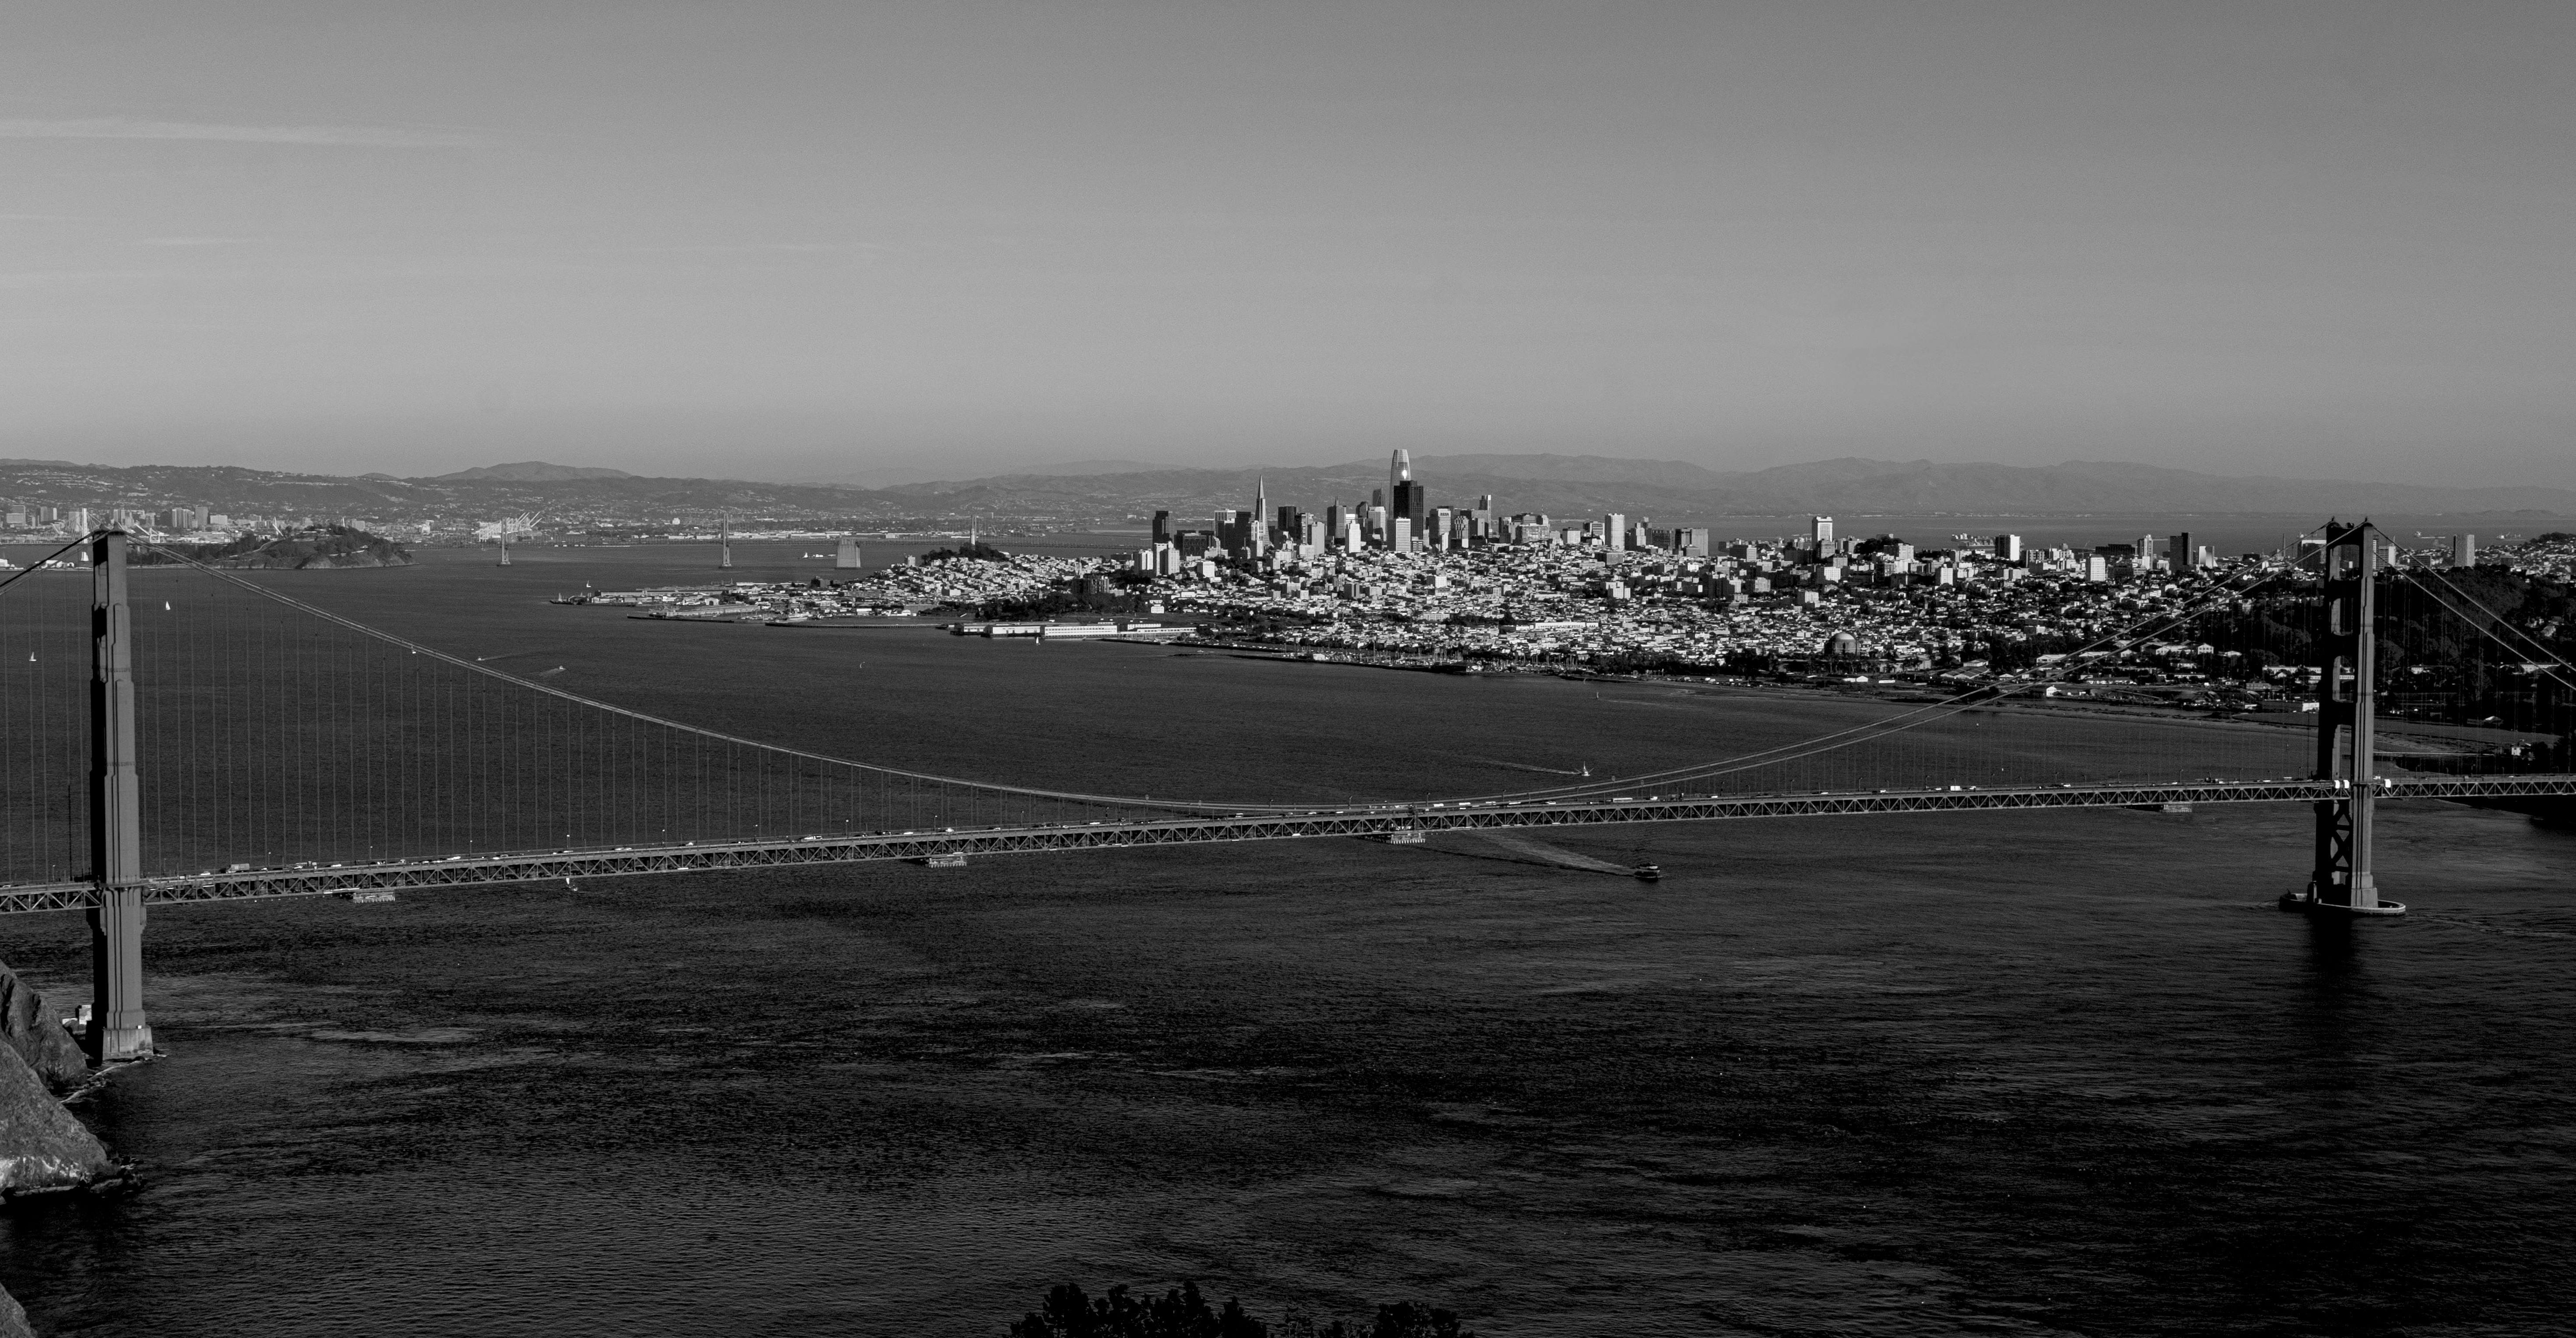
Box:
0, 523, 2576, 1062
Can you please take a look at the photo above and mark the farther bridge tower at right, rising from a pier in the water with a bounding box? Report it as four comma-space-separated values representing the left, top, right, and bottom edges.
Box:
2306, 521, 2406, 915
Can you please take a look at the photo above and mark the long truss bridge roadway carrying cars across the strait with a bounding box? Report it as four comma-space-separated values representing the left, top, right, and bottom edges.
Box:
0, 773, 2576, 915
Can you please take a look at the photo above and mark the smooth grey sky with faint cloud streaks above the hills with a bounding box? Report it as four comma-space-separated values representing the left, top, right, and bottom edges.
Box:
0, 0, 2576, 487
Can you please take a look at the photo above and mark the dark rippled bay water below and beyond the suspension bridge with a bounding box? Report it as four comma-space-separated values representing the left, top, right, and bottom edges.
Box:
0, 547, 2576, 1335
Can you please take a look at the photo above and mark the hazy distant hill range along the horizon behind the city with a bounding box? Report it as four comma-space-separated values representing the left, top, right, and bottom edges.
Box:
0, 454, 2576, 526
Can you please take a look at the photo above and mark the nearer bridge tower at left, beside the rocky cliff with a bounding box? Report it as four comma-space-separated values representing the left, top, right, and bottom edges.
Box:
88, 528, 152, 1065
